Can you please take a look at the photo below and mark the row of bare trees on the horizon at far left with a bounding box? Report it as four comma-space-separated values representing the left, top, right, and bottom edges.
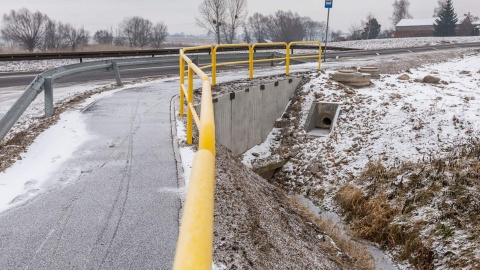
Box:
0, 8, 168, 52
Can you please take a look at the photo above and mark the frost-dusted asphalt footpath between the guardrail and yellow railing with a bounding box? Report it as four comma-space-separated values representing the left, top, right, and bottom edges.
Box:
0, 81, 181, 270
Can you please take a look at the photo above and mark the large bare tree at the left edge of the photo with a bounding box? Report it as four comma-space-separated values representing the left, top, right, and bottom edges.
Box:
1, 8, 49, 52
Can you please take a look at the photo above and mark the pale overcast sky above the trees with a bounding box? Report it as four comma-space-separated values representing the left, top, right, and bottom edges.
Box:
0, 0, 480, 34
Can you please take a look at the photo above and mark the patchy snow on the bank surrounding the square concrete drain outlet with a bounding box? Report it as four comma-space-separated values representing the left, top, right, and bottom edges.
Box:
243, 53, 480, 269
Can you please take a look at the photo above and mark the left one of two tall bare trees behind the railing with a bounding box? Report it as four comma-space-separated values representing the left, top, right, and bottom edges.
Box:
196, 0, 228, 44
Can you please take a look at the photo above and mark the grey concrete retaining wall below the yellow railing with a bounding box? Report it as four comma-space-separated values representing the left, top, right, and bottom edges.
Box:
196, 78, 301, 155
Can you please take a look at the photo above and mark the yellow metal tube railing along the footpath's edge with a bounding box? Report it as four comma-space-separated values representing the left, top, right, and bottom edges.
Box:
173, 42, 322, 270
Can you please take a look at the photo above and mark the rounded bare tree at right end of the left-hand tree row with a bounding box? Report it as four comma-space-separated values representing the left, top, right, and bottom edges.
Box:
119, 16, 153, 48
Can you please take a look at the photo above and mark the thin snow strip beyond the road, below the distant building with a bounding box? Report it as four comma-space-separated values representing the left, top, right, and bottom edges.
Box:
328, 36, 480, 50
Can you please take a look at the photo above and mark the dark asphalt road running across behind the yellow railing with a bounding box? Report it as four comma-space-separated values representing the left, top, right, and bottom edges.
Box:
0, 42, 480, 88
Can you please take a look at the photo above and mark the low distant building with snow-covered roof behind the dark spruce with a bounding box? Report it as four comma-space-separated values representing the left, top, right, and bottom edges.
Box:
395, 16, 475, 38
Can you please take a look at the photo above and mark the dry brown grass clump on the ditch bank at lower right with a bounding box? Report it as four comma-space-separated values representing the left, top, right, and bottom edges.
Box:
335, 137, 480, 269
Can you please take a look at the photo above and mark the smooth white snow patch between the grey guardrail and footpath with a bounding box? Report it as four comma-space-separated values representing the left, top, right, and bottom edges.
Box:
0, 87, 125, 212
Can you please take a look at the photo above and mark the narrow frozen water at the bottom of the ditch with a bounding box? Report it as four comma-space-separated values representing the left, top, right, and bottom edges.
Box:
295, 195, 400, 270
